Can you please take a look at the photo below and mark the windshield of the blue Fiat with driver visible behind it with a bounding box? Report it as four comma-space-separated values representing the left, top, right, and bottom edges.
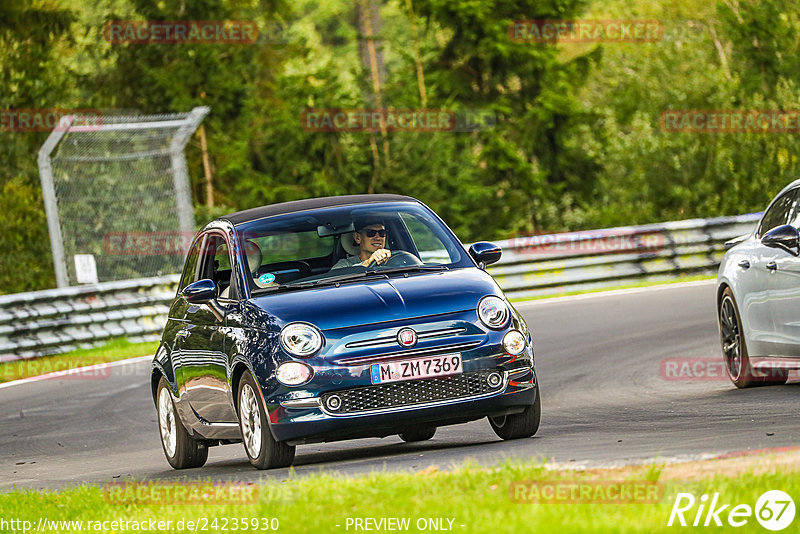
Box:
231, 202, 474, 293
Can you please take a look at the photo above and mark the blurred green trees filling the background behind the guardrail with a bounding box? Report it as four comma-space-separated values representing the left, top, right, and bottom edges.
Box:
0, 0, 800, 293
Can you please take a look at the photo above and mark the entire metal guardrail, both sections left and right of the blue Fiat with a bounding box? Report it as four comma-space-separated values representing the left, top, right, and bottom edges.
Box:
0, 213, 760, 361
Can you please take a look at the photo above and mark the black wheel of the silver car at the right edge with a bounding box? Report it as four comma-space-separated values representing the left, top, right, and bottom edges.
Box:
717, 287, 789, 388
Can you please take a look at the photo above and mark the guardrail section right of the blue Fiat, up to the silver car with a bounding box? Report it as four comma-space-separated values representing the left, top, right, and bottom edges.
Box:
488, 213, 761, 299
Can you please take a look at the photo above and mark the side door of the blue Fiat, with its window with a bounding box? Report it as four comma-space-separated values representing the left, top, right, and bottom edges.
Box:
177, 231, 236, 423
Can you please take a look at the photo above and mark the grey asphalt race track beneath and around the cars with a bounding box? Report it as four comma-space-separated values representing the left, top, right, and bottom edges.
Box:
0, 282, 800, 491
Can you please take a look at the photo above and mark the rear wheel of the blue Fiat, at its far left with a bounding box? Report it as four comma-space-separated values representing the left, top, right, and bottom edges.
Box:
156, 376, 208, 469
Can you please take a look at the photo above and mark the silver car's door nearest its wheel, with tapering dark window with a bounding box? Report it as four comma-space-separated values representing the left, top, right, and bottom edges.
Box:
747, 190, 796, 356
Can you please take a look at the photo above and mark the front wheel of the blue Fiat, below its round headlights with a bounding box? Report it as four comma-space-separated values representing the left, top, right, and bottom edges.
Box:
236, 371, 295, 469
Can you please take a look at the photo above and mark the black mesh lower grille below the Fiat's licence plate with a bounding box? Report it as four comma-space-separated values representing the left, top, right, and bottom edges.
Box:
321, 370, 505, 415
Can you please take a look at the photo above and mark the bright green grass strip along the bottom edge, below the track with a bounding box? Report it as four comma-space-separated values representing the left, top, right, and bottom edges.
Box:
0, 461, 800, 534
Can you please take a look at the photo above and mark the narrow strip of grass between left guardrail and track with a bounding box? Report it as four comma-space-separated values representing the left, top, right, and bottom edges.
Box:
0, 339, 158, 386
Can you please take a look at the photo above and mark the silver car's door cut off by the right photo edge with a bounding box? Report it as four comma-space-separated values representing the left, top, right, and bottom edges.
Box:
767, 189, 800, 357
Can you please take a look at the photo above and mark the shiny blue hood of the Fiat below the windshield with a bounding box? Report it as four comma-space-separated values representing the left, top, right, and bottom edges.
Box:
250, 268, 502, 330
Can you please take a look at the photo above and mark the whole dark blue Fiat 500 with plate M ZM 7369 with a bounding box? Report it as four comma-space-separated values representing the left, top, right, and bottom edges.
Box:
151, 195, 540, 469
